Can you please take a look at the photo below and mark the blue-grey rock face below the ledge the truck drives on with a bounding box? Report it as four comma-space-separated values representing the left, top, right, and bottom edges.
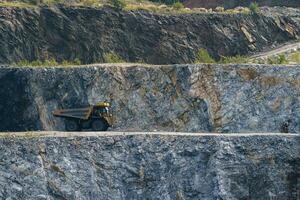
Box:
0, 134, 300, 200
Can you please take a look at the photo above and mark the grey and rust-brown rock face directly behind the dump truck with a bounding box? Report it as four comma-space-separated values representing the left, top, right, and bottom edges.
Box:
0, 64, 300, 133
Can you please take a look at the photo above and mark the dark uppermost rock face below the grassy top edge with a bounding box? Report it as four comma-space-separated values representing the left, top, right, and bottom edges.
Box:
0, 7, 300, 64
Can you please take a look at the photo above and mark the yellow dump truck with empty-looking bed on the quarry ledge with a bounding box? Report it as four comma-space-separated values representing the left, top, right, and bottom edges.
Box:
52, 102, 113, 131
